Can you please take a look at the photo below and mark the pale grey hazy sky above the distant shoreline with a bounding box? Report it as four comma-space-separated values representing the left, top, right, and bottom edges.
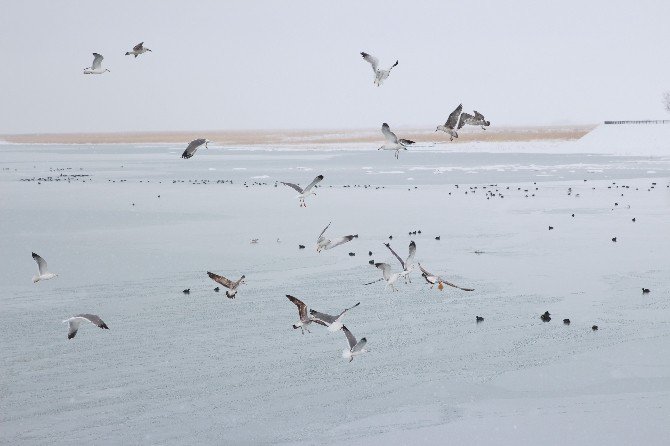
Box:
0, 0, 670, 134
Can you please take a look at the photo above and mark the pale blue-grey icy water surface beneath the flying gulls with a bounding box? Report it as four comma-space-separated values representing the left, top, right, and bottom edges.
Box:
0, 138, 670, 445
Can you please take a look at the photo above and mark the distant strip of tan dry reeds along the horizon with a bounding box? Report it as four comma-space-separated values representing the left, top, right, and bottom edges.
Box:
0, 125, 595, 146
